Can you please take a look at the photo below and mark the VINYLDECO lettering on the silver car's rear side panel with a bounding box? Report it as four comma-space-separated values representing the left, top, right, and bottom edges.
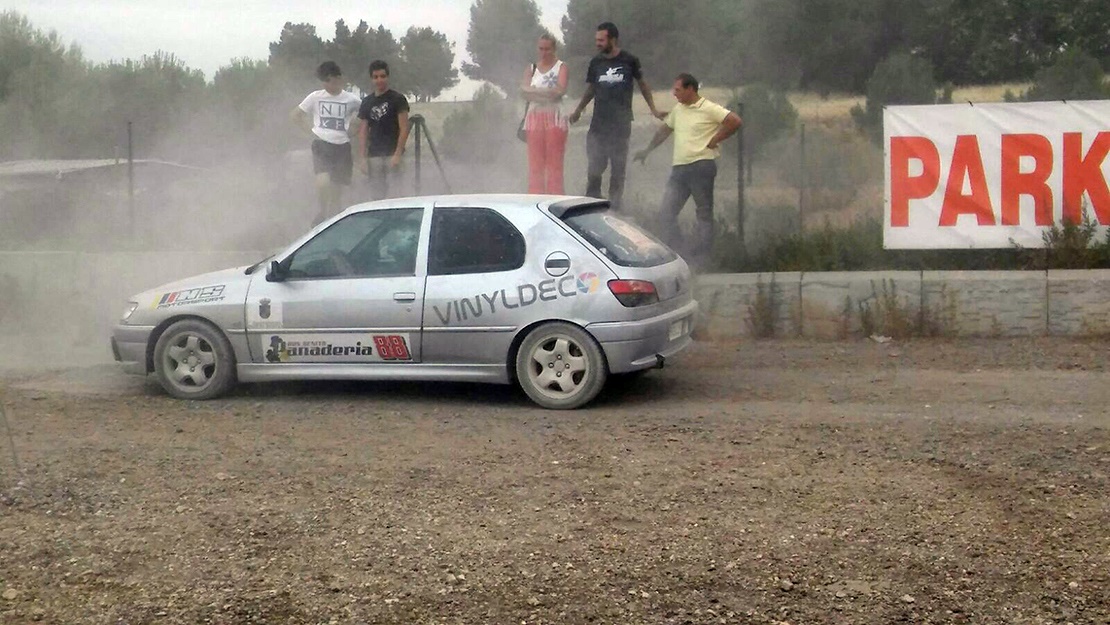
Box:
432, 272, 602, 325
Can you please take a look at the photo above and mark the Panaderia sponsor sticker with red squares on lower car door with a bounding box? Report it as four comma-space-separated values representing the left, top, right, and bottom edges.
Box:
262, 334, 412, 363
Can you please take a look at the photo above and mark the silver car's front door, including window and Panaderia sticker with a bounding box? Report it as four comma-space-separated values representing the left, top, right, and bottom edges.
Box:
245, 208, 427, 364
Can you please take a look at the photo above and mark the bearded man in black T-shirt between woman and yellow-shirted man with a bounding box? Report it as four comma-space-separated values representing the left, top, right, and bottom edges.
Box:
569, 22, 666, 209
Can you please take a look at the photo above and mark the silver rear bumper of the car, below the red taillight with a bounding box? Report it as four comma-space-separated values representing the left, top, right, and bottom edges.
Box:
586, 301, 698, 373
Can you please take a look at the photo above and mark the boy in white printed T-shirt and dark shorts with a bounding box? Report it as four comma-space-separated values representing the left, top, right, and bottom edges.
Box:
290, 61, 362, 223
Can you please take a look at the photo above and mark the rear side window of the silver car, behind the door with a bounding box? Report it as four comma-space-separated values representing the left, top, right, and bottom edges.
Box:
427, 209, 525, 275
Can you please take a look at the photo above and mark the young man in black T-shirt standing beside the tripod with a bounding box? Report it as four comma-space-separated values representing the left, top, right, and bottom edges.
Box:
359, 61, 408, 200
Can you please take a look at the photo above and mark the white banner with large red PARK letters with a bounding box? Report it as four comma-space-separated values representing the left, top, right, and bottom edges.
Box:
882, 100, 1110, 249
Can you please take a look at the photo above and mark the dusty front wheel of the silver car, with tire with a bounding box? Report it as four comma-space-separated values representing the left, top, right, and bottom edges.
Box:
154, 319, 236, 400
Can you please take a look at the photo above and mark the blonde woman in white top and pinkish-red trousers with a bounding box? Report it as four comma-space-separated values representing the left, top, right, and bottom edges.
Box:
521, 33, 567, 195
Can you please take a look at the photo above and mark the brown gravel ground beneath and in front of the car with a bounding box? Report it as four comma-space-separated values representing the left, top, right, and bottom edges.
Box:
0, 339, 1110, 625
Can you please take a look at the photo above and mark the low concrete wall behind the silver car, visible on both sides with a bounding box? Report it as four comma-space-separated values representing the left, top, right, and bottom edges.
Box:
0, 252, 1110, 353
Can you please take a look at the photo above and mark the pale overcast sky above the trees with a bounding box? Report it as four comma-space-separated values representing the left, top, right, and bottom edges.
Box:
0, 0, 567, 99
